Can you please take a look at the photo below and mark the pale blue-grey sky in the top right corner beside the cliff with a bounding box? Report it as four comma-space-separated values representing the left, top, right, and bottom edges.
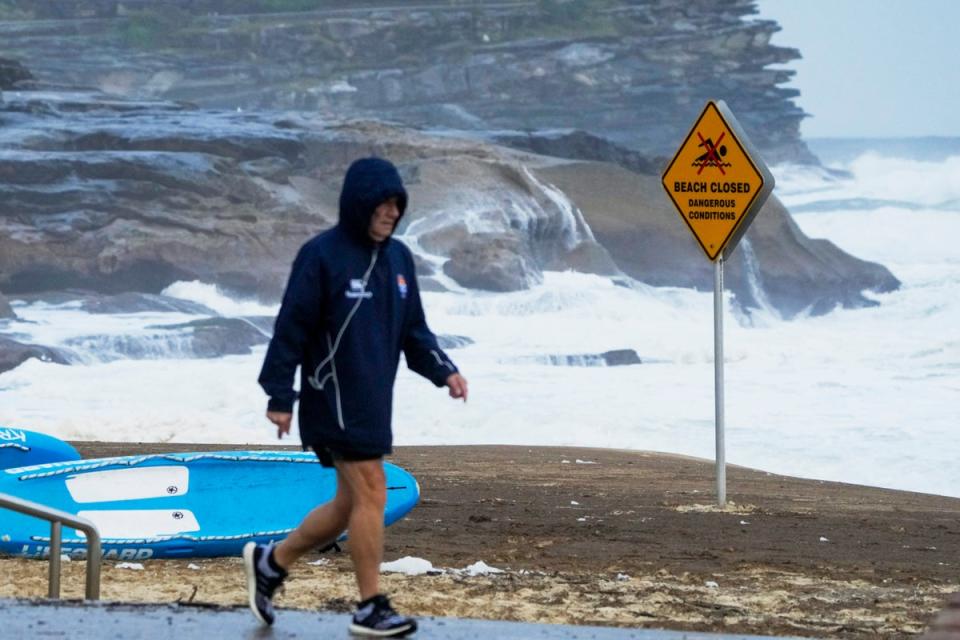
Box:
757, 0, 960, 138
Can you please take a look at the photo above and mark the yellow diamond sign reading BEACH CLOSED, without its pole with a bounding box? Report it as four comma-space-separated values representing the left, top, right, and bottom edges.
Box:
663, 100, 773, 260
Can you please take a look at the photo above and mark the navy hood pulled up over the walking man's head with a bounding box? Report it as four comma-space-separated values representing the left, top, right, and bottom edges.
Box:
339, 158, 407, 244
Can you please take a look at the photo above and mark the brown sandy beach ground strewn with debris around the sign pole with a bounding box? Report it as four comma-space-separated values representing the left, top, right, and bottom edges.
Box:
0, 443, 960, 638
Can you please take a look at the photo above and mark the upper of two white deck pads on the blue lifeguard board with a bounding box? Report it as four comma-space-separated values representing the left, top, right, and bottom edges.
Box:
66, 465, 190, 504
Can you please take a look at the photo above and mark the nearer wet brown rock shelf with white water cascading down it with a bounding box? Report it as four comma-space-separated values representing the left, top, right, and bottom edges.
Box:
0, 91, 897, 316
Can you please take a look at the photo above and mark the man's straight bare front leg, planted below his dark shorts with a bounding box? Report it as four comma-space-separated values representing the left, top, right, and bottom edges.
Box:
335, 459, 387, 600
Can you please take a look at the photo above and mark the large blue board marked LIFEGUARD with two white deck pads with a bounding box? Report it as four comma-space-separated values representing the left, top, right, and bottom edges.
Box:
0, 451, 420, 560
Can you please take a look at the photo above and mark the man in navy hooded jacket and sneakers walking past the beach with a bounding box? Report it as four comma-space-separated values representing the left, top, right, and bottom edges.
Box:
243, 158, 467, 637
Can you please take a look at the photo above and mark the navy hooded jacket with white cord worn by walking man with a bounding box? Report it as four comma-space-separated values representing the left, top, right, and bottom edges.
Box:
259, 158, 457, 456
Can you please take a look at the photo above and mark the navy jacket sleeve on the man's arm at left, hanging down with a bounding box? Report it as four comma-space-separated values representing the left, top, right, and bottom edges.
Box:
258, 247, 324, 413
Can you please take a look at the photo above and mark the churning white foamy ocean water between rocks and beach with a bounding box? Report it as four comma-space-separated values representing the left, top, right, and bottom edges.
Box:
0, 140, 960, 500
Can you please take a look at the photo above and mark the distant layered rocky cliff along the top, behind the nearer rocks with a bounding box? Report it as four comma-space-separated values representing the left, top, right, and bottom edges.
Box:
0, 0, 815, 163
